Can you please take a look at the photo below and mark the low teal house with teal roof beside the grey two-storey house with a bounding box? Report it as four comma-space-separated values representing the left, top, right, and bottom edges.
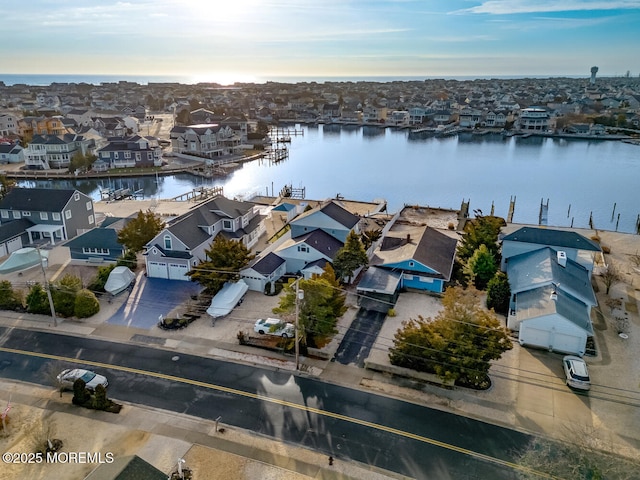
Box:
64, 217, 129, 265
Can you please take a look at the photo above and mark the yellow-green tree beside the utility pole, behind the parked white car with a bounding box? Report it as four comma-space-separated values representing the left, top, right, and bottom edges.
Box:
273, 265, 346, 347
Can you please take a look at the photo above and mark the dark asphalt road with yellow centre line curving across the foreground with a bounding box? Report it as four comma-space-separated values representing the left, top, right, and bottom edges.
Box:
0, 327, 530, 479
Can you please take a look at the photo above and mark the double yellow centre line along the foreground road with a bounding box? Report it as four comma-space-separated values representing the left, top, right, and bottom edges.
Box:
0, 347, 561, 480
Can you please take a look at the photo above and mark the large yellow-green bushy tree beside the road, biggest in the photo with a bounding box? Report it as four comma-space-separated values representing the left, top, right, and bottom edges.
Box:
389, 287, 512, 386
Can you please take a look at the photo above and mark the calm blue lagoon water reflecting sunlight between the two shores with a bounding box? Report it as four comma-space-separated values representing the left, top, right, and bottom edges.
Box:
18, 125, 640, 232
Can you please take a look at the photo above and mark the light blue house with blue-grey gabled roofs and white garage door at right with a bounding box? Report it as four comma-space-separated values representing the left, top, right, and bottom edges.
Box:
507, 247, 597, 356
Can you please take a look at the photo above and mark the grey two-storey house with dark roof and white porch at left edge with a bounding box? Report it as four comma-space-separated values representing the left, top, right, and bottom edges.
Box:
0, 188, 95, 244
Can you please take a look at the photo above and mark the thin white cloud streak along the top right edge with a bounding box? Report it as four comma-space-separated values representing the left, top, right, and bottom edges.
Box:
451, 0, 640, 15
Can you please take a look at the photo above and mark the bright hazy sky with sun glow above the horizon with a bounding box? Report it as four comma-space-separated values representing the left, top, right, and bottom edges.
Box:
0, 0, 640, 84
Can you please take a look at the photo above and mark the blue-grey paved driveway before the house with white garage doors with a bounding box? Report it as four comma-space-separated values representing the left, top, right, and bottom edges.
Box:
107, 273, 202, 330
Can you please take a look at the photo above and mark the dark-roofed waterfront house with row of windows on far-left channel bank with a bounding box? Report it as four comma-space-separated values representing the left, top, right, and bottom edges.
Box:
96, 135, 162, 168
